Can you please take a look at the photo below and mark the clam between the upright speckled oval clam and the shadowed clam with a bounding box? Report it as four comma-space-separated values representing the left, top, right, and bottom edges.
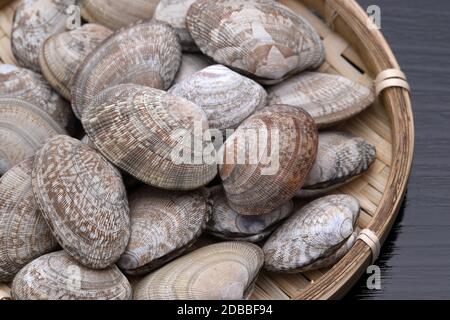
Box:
117, 186, 210, 274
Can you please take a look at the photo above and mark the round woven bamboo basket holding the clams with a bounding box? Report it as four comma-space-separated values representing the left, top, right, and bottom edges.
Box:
0, 0, 414, 300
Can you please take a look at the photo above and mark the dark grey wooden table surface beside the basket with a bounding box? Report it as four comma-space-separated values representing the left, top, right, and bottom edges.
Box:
347, 0, 450, 299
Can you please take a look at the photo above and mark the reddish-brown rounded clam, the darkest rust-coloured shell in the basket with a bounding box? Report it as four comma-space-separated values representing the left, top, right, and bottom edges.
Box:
218, 105, 317, 215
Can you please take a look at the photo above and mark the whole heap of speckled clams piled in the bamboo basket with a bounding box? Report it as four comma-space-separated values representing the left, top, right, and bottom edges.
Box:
0, 0, 376, 299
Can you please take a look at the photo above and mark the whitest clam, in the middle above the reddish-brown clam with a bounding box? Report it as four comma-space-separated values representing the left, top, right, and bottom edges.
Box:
169, 65, 267, 131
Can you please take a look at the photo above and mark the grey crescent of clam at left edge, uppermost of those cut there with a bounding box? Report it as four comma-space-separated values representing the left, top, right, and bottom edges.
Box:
0, 64, 75, 132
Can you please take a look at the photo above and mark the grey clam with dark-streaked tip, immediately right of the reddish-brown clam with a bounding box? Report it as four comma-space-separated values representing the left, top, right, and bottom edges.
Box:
297, 131, 376, 197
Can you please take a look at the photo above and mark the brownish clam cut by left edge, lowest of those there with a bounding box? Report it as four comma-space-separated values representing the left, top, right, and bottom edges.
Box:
0, 157, 58, 282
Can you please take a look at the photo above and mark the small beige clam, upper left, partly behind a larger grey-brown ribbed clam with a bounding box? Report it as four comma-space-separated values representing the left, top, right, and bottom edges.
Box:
39, 23, 112, 100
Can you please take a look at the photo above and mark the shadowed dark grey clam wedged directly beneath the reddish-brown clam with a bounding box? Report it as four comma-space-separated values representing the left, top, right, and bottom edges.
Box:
206, 187, 294, 242
